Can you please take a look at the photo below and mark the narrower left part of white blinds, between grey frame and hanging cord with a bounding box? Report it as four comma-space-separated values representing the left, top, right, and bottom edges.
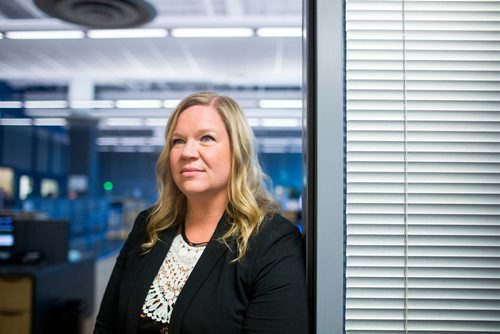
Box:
345, 0, 406, 333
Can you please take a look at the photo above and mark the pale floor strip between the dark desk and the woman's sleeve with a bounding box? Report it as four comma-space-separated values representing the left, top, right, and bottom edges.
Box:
82, 252, 118, 334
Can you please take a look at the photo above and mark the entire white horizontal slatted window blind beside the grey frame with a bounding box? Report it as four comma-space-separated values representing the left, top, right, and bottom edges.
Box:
345, 0, 500, 333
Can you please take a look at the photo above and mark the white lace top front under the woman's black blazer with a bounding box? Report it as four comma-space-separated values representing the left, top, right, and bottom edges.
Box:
142, 234, 206, 323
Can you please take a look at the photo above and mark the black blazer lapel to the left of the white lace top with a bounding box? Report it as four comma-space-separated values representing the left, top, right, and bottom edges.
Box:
126, 226, 177, 334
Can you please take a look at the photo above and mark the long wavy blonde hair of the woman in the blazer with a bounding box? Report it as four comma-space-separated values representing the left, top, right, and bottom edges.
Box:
142, 92, 278, 261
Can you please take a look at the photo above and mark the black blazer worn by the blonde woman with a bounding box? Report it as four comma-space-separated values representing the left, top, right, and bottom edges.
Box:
94, 211, 309, 334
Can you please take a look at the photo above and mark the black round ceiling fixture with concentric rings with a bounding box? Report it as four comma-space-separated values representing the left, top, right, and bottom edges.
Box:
34, 0, 156, 29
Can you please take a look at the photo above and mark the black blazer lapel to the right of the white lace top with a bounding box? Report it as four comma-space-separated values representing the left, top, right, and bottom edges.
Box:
169, 214, 229, 334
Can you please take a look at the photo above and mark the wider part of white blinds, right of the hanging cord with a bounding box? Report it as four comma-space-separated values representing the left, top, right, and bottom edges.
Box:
405, 1, 500, 333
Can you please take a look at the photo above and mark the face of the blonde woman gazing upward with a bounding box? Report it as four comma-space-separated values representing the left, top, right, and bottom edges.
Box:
167, 105, 231, 198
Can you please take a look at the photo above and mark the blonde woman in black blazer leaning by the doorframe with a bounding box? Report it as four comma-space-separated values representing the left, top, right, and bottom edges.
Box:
94, 92, 308, 334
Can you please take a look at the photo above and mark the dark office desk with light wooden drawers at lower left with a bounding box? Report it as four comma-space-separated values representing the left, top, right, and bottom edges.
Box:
0, 257, 95, 334
